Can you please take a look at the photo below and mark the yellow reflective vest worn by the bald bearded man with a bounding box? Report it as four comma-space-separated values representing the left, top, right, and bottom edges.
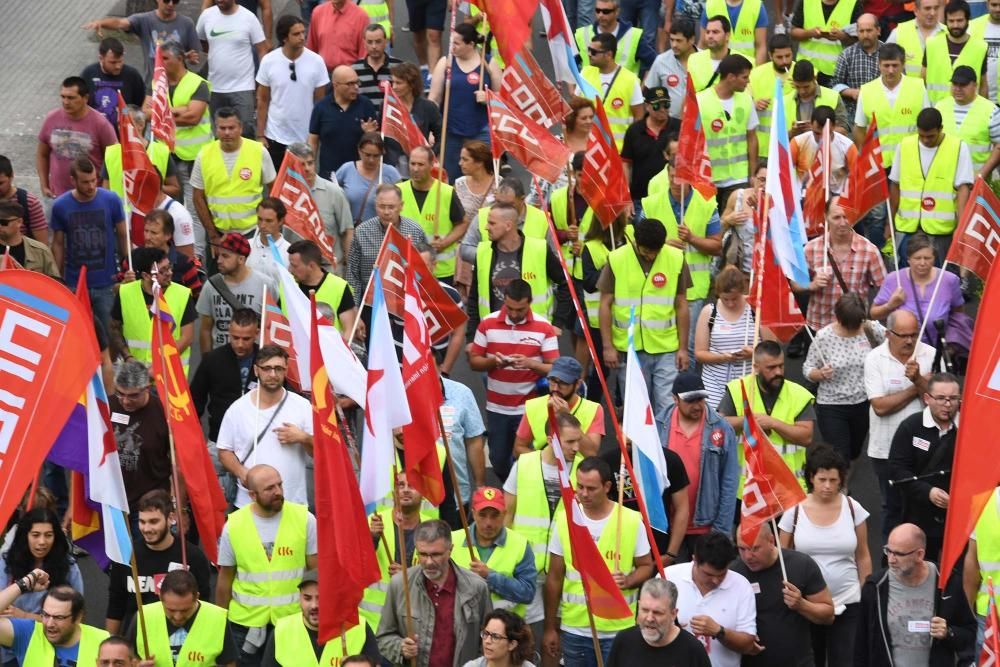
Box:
229, 500, 308, 628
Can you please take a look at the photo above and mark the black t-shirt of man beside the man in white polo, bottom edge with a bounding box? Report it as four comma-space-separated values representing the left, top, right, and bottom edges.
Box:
729, 550, 826, 667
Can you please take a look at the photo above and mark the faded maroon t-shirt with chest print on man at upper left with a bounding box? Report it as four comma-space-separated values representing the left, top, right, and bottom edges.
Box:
38, 107, 118, 196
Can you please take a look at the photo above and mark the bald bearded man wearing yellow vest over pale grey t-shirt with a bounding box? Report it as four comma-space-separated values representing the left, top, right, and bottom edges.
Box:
215, 464, 318, 666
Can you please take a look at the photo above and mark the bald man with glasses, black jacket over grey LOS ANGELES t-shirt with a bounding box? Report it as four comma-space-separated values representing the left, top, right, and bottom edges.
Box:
854, 523, 976, 667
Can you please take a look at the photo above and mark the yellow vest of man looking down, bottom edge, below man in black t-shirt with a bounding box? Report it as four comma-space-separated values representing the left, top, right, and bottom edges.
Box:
136, 601, 227, 667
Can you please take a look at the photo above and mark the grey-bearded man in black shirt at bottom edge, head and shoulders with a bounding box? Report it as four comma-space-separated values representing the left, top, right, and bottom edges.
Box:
607, 579, 712, 667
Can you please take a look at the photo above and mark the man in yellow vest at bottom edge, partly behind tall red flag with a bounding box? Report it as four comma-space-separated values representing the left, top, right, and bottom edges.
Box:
261, 570, 379, 667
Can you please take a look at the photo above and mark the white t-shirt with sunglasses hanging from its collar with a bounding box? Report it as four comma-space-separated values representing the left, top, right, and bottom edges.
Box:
257, 49, 330, 145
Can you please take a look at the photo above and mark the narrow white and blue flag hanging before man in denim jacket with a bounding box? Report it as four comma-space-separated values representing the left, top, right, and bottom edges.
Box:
622, 306, 670, 533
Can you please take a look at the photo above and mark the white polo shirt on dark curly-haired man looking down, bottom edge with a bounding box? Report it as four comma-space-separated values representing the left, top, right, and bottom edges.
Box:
664, 563, 757, 667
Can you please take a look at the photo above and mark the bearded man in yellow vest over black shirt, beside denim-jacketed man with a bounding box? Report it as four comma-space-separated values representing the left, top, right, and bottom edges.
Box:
719, 340, 816, 490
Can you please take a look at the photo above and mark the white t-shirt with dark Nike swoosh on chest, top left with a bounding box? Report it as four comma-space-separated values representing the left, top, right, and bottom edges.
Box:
196, 5, 264, 93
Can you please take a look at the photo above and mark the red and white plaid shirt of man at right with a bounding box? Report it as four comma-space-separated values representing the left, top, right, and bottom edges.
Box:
806, 232, 885, 331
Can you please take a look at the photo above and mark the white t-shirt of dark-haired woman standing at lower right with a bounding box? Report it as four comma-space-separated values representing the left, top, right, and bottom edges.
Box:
778, 495, 868, 614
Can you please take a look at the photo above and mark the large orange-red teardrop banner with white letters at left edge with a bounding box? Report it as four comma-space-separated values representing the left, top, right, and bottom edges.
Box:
0, 271, 101, 523
